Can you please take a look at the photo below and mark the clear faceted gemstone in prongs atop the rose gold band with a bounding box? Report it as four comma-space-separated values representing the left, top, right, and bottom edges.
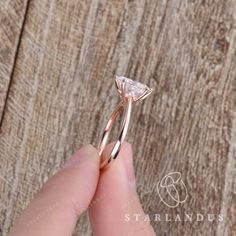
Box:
116, 76, 152, 101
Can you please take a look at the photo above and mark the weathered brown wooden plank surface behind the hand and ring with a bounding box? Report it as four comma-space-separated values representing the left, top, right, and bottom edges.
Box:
0, 0, 236, 236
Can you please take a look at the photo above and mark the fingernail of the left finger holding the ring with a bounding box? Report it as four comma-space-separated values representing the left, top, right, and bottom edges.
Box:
65, 144, 96, 167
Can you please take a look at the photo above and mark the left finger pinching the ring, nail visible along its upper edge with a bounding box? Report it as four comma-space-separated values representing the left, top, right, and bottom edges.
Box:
10, 145, 100, 236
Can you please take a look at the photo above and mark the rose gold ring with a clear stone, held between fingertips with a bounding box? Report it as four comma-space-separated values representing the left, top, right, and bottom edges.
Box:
98, 76, 153, 169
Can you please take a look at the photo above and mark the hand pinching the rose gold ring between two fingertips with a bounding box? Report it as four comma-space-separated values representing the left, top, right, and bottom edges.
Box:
10, 143, 155, 236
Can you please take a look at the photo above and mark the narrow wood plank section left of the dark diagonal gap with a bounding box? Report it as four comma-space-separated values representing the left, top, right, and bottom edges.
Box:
0, 0, 28, 123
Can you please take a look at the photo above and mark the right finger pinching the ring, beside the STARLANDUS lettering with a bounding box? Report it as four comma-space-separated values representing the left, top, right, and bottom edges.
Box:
89, 143, 155, 236
